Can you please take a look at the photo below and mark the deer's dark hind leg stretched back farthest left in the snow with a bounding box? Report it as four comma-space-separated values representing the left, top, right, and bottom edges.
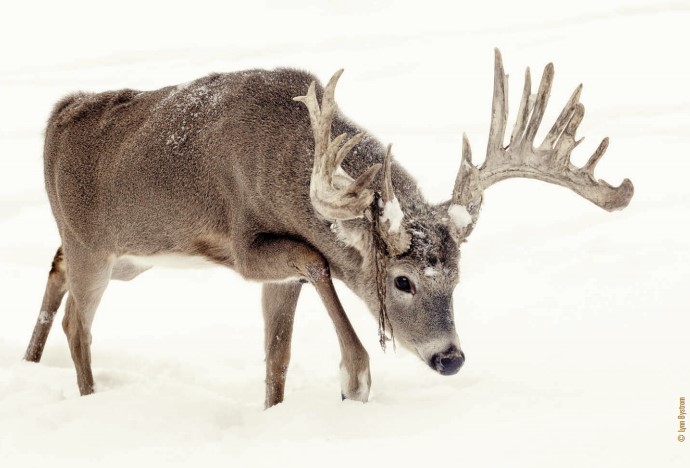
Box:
24, 247, 67, 362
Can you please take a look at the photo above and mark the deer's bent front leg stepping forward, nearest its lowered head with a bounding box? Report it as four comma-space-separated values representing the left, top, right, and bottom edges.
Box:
235, 236, 371, 405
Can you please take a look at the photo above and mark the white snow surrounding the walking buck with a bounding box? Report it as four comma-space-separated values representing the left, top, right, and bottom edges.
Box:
0, 0, 690, 468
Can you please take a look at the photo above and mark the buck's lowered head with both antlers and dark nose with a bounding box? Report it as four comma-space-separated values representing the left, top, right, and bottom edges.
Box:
295, 50, 633, 375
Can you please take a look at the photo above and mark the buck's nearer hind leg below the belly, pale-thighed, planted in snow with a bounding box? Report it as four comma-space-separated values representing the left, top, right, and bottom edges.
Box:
62, 245, 114, 395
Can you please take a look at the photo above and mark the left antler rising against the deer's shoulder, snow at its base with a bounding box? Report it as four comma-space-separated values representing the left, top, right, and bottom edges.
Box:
293, 69, 410, 255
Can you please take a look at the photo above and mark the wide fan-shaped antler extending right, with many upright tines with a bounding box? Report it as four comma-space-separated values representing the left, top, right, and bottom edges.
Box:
449, 49, 634, 236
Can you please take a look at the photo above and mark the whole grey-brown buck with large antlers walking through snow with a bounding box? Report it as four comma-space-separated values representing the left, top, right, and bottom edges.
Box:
25, 50, 633, 407
